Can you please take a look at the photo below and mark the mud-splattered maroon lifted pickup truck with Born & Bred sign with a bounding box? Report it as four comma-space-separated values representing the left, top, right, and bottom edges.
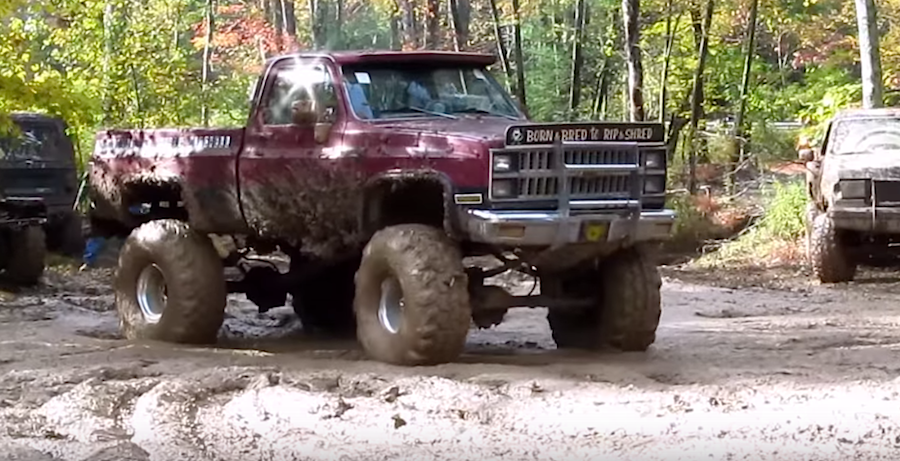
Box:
90, 52, 674, 365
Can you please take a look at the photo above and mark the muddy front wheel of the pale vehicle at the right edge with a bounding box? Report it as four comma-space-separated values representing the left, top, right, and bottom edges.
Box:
809, 213, 856, 283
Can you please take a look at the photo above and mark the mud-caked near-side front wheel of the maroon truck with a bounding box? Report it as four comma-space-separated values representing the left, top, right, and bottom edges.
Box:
354, 224, 472, 366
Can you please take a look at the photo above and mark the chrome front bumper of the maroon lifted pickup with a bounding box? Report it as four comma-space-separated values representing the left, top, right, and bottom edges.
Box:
464, 210, 676, 247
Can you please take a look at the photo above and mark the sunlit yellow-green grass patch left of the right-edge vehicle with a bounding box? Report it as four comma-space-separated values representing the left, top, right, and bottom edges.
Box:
693, 179, 806, 268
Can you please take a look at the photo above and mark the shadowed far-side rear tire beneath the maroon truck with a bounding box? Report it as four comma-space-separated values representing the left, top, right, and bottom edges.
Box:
291, 258, 360, 338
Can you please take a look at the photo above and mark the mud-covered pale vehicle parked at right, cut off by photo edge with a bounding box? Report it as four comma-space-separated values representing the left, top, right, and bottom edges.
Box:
799, 109, 900, 283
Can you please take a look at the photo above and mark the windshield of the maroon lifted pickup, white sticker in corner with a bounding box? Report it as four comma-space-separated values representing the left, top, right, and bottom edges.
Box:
343, 65, 522, 120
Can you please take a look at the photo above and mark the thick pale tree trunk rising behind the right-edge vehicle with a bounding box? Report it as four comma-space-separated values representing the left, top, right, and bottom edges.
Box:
856, 0, 884, 108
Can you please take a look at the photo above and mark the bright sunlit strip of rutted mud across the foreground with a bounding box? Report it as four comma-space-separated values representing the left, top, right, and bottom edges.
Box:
6, 368, 900, 461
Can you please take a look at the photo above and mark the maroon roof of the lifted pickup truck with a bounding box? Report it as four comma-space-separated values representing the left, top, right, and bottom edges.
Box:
270, 50, 497, 66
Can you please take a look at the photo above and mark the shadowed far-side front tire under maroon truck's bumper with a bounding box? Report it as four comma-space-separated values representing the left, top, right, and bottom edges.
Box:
547, 247, 662, 351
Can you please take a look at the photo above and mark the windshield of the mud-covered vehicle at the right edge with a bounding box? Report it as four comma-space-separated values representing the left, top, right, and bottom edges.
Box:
826, 117, 900, 155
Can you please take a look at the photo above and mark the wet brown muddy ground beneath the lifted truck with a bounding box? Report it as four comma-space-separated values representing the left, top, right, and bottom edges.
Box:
0, 262, 900, 461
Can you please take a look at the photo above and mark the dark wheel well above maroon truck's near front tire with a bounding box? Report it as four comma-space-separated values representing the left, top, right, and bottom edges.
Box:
363, 176, 449, 233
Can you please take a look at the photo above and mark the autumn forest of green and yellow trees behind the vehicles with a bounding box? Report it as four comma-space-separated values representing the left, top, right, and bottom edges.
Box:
0, 0, 888, 264
